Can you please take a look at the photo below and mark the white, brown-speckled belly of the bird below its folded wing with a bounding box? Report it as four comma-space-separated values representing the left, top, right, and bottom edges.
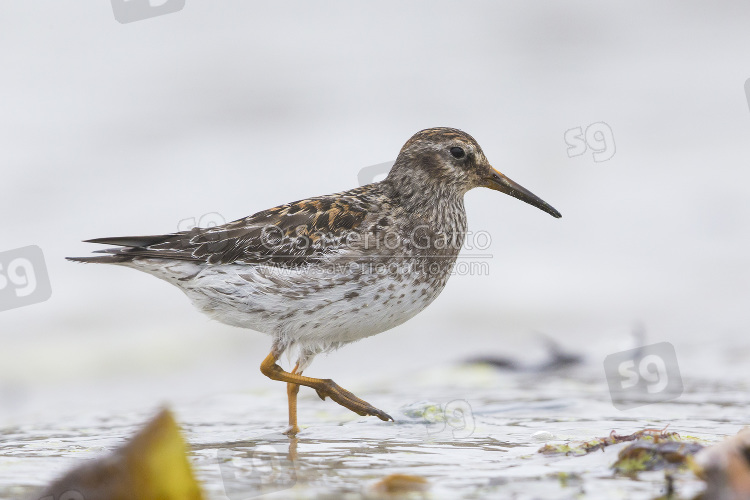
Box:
128, 260, 447, 352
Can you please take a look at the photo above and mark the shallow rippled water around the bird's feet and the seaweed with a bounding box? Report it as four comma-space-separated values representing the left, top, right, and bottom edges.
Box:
0, 358, 749, 500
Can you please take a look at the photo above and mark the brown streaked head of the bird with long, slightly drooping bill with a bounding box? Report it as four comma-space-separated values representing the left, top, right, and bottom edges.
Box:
386, 127, 562, 218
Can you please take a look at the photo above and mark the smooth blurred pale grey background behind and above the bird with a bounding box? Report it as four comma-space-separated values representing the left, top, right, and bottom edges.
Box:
0, 0, 750, 423
